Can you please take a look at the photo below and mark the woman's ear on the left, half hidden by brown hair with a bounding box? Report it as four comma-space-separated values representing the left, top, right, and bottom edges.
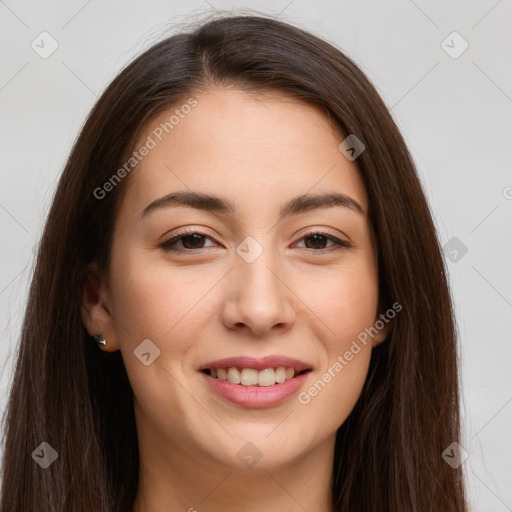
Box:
81, 263, 120, 352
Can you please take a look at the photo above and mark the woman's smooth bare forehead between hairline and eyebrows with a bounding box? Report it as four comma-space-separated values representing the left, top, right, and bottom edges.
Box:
120, 89, 367, 220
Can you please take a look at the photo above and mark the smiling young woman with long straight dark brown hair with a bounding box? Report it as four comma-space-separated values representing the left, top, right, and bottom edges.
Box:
1, 16, 467, 512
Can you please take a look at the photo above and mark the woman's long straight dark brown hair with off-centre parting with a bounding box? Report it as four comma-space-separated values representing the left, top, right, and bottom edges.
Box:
1, 16, 467, 512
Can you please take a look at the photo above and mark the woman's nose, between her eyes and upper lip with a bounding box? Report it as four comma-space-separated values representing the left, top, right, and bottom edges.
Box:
222, 250, 296, 336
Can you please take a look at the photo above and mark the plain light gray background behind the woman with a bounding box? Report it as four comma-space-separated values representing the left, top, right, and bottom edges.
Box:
0, 0, 512, 512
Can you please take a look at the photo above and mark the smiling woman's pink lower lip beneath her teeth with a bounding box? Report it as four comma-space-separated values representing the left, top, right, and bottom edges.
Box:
200, 371, 311, 407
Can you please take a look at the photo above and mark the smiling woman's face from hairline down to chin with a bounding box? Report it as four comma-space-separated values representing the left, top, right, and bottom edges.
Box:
85, 89, 388, 468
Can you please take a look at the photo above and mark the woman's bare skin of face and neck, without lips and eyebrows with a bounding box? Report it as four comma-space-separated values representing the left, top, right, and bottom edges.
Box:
83, 89, 390, 512
